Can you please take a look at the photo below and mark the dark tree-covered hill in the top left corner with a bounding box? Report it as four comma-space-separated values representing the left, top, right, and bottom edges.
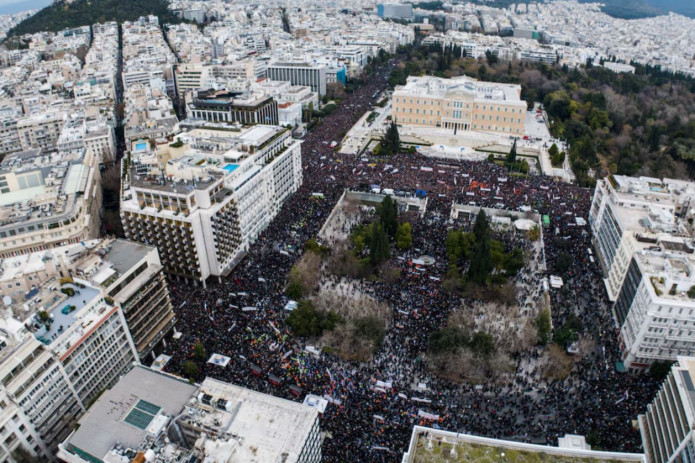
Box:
7, 0, 181, 37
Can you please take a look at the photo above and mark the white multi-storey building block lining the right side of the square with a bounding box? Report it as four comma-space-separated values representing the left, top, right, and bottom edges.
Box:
589, 175, 695, 368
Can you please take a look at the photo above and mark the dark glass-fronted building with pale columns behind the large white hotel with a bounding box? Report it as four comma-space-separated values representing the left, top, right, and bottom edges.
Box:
188, 90, 279, 125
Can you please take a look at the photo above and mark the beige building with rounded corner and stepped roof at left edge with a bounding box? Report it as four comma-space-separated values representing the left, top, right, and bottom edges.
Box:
0, 148, 102, 259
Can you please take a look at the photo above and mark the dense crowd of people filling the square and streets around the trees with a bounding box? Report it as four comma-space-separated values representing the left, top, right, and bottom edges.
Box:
164, 57, 656, 462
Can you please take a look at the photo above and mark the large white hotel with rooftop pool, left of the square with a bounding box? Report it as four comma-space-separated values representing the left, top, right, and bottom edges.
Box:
121, 125, 302, 285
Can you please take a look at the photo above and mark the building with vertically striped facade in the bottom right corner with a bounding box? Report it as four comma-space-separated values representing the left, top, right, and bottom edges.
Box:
639, 357, 695, 463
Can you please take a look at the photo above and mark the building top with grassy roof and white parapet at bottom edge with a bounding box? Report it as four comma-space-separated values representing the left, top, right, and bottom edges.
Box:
402, 426, 648, 463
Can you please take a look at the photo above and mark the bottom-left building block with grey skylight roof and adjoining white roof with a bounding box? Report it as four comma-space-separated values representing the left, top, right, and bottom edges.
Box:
58, 366, 321, 463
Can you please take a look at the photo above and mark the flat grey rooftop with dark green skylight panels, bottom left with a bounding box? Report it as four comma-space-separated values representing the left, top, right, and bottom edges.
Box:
65, 365, 197, 460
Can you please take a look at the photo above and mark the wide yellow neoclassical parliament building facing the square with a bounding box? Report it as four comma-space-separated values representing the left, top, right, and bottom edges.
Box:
392, 76, 527, 136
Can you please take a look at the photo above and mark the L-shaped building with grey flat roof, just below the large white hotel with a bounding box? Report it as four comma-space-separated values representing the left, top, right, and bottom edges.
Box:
0, 238, 176, 360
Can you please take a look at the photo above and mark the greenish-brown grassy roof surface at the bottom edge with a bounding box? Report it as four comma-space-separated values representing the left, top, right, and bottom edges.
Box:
412, 437, 640, 463
